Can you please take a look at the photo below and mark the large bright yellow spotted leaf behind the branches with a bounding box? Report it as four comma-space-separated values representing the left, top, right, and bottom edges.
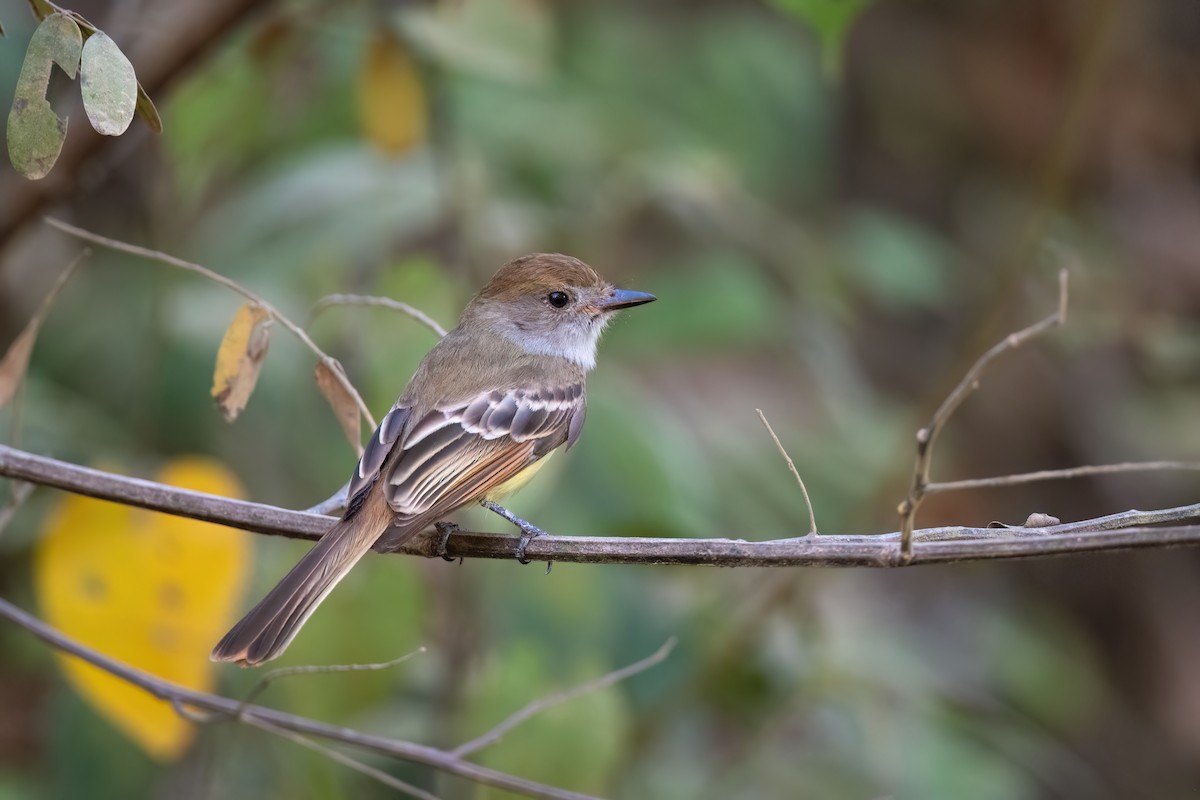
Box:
34, 458, 252, 760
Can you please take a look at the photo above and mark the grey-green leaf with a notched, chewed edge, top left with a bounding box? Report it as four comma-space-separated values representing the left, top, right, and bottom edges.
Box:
8, 14, 83, 181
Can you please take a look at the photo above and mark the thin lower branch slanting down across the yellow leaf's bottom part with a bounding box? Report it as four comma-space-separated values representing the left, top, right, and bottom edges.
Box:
0, 599, 589, 800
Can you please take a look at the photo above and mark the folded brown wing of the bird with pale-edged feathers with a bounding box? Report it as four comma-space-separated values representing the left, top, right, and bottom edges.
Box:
350, 383, 586, 551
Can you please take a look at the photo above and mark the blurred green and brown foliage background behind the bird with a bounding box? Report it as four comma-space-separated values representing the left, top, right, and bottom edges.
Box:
0, 0, 1200, 799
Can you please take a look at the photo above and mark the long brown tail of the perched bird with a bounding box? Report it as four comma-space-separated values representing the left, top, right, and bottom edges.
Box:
210, 487, 392, 667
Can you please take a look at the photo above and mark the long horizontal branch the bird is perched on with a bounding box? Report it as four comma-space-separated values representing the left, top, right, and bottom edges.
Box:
0, 445, 1200, 567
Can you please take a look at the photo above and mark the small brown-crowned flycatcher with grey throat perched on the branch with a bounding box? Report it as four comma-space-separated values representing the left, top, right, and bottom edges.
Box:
212, 253, 655, 666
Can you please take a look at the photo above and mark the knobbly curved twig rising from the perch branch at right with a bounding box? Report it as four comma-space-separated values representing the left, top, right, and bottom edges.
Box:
896, 269, 1067, 564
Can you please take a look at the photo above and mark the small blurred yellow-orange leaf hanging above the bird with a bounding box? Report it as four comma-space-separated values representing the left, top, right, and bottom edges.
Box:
359, 30, 427, 154
